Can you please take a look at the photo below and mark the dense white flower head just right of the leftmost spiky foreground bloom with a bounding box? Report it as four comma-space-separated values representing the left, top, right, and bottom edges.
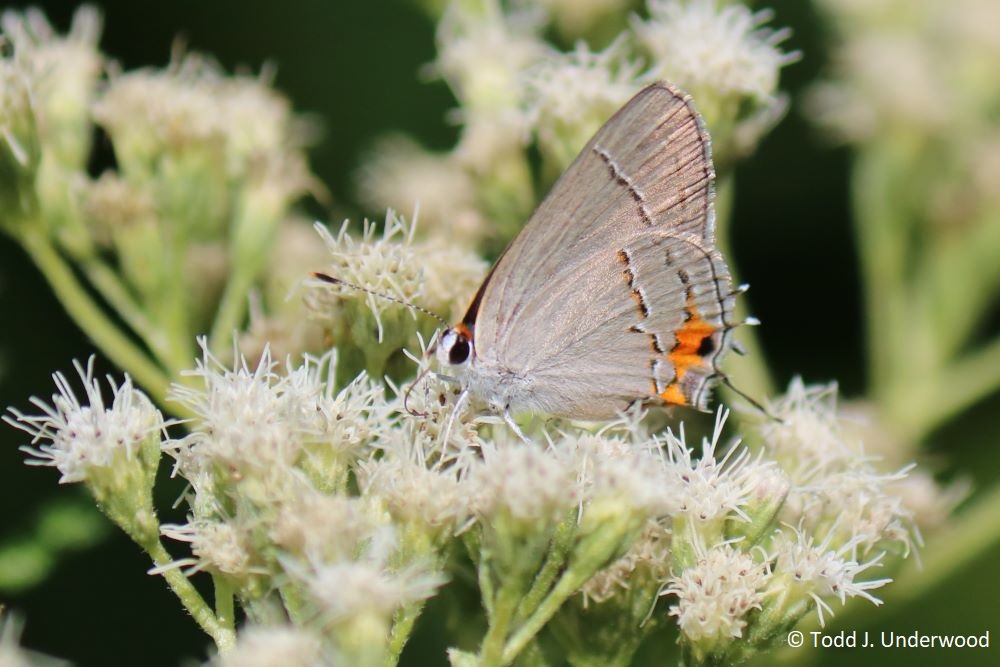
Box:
164, 340, 390, 495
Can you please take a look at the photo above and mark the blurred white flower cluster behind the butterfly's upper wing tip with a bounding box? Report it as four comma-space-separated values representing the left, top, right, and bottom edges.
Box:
358, 0, 798, 249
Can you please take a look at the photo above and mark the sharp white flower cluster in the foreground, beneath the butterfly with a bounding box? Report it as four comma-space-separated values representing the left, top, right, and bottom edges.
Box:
6, 332, 928, 658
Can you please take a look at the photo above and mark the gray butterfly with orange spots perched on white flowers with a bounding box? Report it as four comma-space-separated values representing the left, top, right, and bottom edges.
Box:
318, 83, 750, 434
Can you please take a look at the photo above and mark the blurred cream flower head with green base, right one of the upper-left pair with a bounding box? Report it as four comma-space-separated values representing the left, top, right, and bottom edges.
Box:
93, 54, 312, 264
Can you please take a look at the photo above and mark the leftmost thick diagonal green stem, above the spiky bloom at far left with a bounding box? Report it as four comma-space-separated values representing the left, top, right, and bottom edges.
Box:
20, 227, 170, 405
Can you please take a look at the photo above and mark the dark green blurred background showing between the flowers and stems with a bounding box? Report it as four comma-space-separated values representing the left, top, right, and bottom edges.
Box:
0, 0, 1000, 667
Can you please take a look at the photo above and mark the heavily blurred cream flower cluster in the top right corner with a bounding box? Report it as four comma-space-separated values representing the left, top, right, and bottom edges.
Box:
809, 0, 1000, 141
